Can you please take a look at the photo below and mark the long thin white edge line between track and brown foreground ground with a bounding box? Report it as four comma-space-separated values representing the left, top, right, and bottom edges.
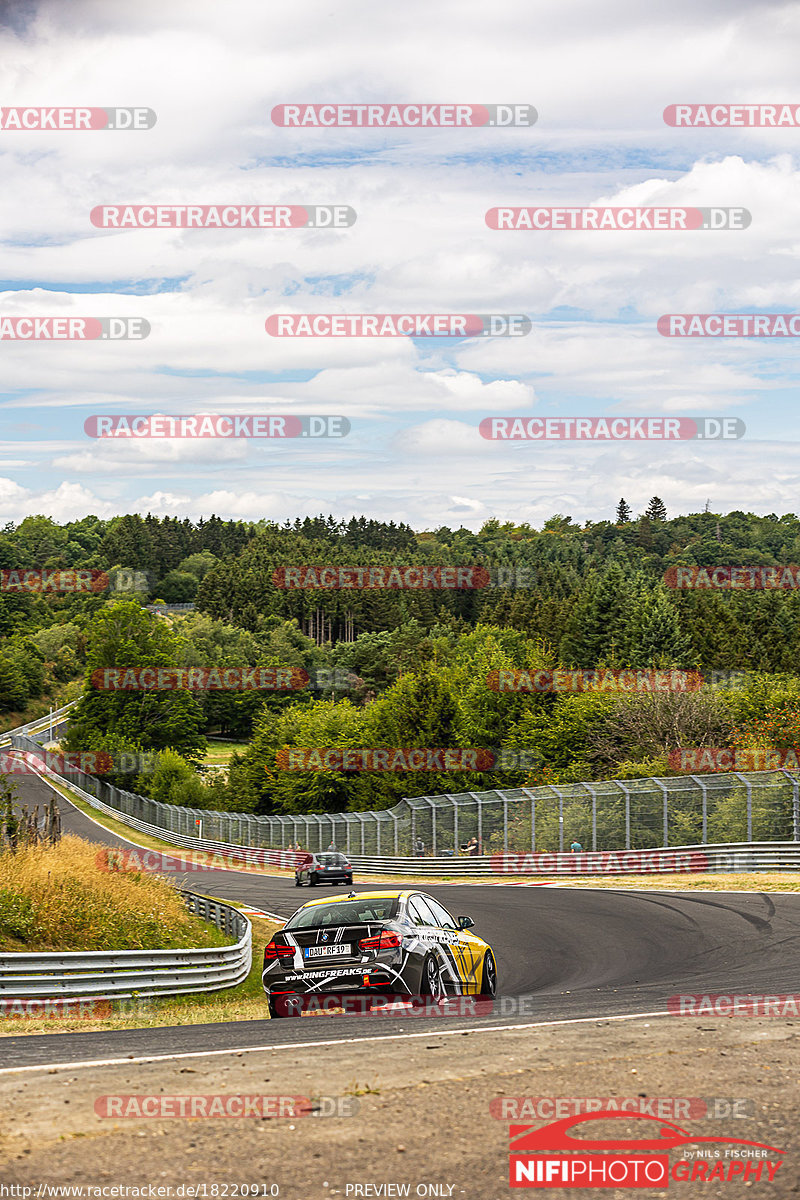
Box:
0, 1009, 674, 1075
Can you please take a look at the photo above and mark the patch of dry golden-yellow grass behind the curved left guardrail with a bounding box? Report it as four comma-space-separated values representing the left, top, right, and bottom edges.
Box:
0, 836, 228, 950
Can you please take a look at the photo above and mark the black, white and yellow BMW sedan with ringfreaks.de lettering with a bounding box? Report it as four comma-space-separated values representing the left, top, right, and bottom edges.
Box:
261, 890, 497, 1016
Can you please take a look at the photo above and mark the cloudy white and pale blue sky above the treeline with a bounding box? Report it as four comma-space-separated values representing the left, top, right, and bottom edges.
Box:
0, 0, 800, 529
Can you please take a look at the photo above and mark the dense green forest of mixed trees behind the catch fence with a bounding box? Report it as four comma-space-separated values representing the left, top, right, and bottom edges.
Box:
0, 497, 800, 812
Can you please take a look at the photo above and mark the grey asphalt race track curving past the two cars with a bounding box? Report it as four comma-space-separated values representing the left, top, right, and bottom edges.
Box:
0, 776, 800, 1068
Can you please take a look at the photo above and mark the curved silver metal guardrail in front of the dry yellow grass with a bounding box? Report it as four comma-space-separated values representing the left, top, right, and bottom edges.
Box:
0, 892, 253, 1000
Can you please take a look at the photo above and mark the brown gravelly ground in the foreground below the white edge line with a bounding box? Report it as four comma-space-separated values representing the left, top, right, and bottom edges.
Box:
0, 1016, 800, 1200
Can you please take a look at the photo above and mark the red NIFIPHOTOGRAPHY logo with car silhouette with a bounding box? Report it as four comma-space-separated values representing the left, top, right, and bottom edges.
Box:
509, 1109, 783, 1188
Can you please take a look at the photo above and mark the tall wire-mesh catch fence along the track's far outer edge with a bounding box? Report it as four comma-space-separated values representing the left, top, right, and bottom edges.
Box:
13, 736, 800, 875
